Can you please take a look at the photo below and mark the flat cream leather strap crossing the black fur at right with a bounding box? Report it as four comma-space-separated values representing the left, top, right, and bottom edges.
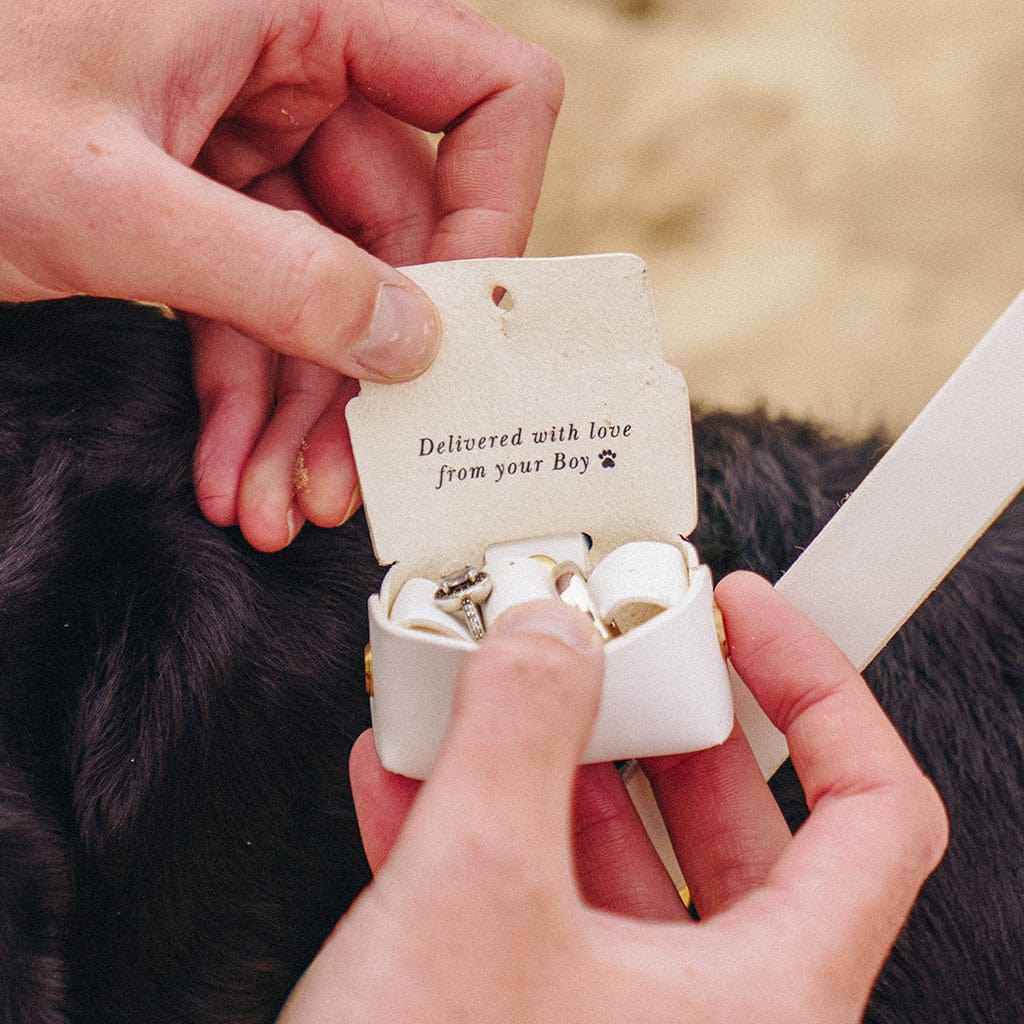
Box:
745, 293, 1024, 775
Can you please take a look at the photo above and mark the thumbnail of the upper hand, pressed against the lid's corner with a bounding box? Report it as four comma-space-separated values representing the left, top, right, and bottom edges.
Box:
352, 285, 440, 380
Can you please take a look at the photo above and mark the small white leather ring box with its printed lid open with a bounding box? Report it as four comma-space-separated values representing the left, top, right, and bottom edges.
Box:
347, 254, 733, 778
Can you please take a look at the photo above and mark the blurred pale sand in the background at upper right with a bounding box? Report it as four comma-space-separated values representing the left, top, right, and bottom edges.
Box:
470, 0, 1024, 429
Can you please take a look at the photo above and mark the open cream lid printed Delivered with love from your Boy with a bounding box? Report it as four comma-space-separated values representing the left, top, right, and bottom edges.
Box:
346, 254, 697, 579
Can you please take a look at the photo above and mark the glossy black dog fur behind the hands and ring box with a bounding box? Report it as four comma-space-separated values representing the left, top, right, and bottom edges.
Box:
0, 299, 1024, 1024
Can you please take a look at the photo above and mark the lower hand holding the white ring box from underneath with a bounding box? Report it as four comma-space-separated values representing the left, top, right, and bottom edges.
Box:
281, 574, 947, 1024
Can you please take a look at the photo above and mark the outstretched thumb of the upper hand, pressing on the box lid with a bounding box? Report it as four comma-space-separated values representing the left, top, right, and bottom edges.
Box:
54, 135, 439, 380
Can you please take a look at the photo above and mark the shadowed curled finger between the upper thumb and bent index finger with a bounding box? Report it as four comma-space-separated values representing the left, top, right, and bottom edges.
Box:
299, 94, 436, 266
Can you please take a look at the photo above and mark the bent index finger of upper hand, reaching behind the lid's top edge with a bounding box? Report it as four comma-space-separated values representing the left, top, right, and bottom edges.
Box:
349, 0, 563, 259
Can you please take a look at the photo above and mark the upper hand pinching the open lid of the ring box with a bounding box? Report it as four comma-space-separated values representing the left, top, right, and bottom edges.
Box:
0, 0, 561, 550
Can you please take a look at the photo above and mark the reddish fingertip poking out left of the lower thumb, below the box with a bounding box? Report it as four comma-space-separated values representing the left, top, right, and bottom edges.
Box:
348, 729, 421, 874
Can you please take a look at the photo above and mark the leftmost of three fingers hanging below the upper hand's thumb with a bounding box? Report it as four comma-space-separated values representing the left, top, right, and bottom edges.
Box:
190, 321, 275, 526
